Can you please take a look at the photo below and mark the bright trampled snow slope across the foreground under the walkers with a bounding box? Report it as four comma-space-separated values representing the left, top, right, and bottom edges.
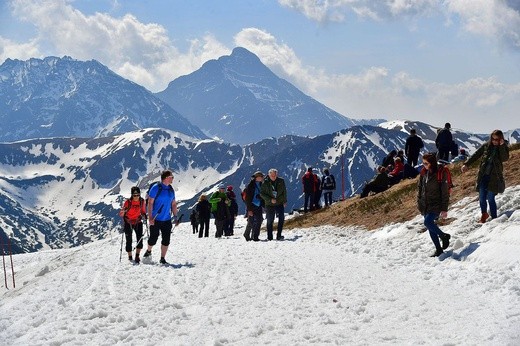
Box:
0, 186, 520, 346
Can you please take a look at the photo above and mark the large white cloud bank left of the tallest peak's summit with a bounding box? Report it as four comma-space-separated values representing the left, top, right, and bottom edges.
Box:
4, 0, 230, 91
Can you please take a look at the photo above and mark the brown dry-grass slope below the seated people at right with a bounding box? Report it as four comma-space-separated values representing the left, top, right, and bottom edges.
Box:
284, 144, 520, 230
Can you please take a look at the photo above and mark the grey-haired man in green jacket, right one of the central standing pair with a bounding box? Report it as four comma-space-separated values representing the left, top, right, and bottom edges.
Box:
260, 168, 287, 240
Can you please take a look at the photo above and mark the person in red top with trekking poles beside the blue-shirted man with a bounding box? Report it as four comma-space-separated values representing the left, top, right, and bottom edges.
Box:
119, 186, 146, 263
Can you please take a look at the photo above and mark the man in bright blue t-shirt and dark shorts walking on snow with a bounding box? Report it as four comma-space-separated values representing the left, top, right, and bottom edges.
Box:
143, 170, 178, 264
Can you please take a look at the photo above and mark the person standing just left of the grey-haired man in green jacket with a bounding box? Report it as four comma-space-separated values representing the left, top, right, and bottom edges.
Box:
244, 171, 264, 241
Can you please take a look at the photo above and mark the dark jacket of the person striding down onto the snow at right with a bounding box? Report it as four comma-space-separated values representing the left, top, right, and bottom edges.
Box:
417, 168, 450, 215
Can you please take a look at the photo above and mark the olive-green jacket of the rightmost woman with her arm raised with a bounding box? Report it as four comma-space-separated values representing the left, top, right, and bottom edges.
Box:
465, 142, 509, 194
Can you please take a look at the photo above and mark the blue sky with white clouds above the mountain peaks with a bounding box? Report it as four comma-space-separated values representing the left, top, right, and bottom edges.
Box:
0, 0, 520, 133
